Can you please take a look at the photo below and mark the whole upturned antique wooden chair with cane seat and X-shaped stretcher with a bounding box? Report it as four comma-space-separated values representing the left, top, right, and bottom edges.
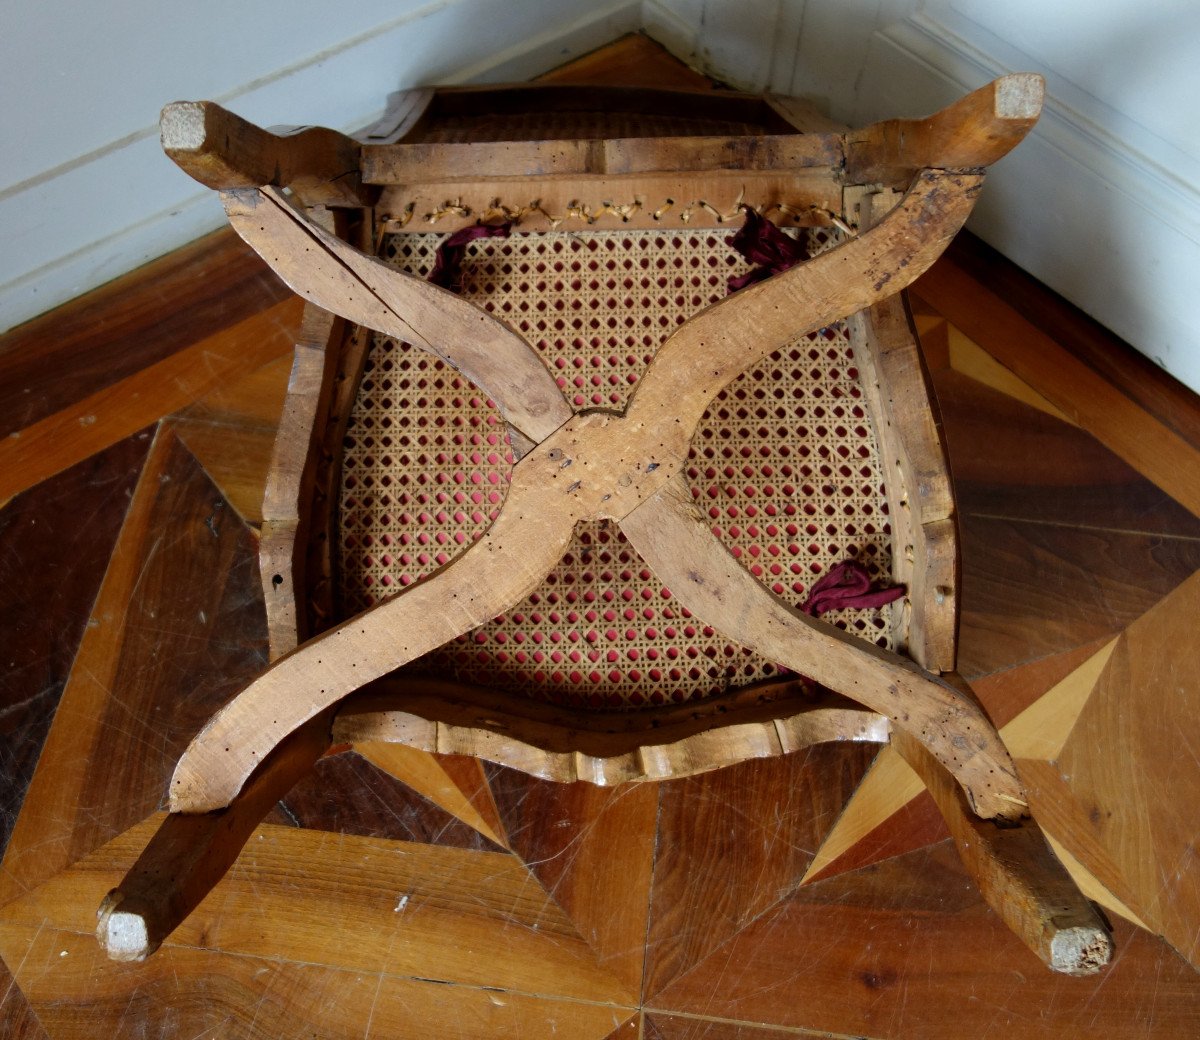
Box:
97, 76, 1109, 974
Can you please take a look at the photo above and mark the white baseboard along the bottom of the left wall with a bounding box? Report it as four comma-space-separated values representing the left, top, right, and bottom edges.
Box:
0, 0, 642, 331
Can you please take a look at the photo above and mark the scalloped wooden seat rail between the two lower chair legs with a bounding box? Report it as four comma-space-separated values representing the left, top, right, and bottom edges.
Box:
332, 677, 890, 787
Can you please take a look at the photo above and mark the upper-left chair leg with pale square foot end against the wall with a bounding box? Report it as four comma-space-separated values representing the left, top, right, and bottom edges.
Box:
160, 101, 376, 206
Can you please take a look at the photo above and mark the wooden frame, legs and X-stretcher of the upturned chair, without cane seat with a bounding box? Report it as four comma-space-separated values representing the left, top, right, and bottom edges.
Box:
97, 76, 1109, 973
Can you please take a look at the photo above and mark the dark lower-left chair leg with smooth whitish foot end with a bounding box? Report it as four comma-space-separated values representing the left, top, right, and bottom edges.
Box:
96, 713, 331, 961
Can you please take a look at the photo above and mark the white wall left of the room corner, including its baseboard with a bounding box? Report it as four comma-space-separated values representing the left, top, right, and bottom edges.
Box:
0, 0, 641, 330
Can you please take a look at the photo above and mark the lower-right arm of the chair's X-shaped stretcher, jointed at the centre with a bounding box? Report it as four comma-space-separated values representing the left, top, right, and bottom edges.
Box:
620, 479, 1026, 819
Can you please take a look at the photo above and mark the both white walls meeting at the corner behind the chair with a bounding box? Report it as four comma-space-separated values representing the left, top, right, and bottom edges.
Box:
0, 0, 1200, 390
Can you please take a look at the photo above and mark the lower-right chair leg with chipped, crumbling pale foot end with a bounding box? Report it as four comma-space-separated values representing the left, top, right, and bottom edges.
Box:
893, 732, 1112, 975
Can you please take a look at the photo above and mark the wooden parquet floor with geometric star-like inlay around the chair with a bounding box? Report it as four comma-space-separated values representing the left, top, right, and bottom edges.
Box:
0, 34, 1200, 1040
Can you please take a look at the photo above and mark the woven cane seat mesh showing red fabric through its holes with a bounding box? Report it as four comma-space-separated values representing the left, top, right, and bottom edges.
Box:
340, 229, 892, 708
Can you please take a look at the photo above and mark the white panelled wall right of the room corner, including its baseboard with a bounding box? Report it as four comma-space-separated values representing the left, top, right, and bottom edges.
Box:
646, 0, 1200, 391
